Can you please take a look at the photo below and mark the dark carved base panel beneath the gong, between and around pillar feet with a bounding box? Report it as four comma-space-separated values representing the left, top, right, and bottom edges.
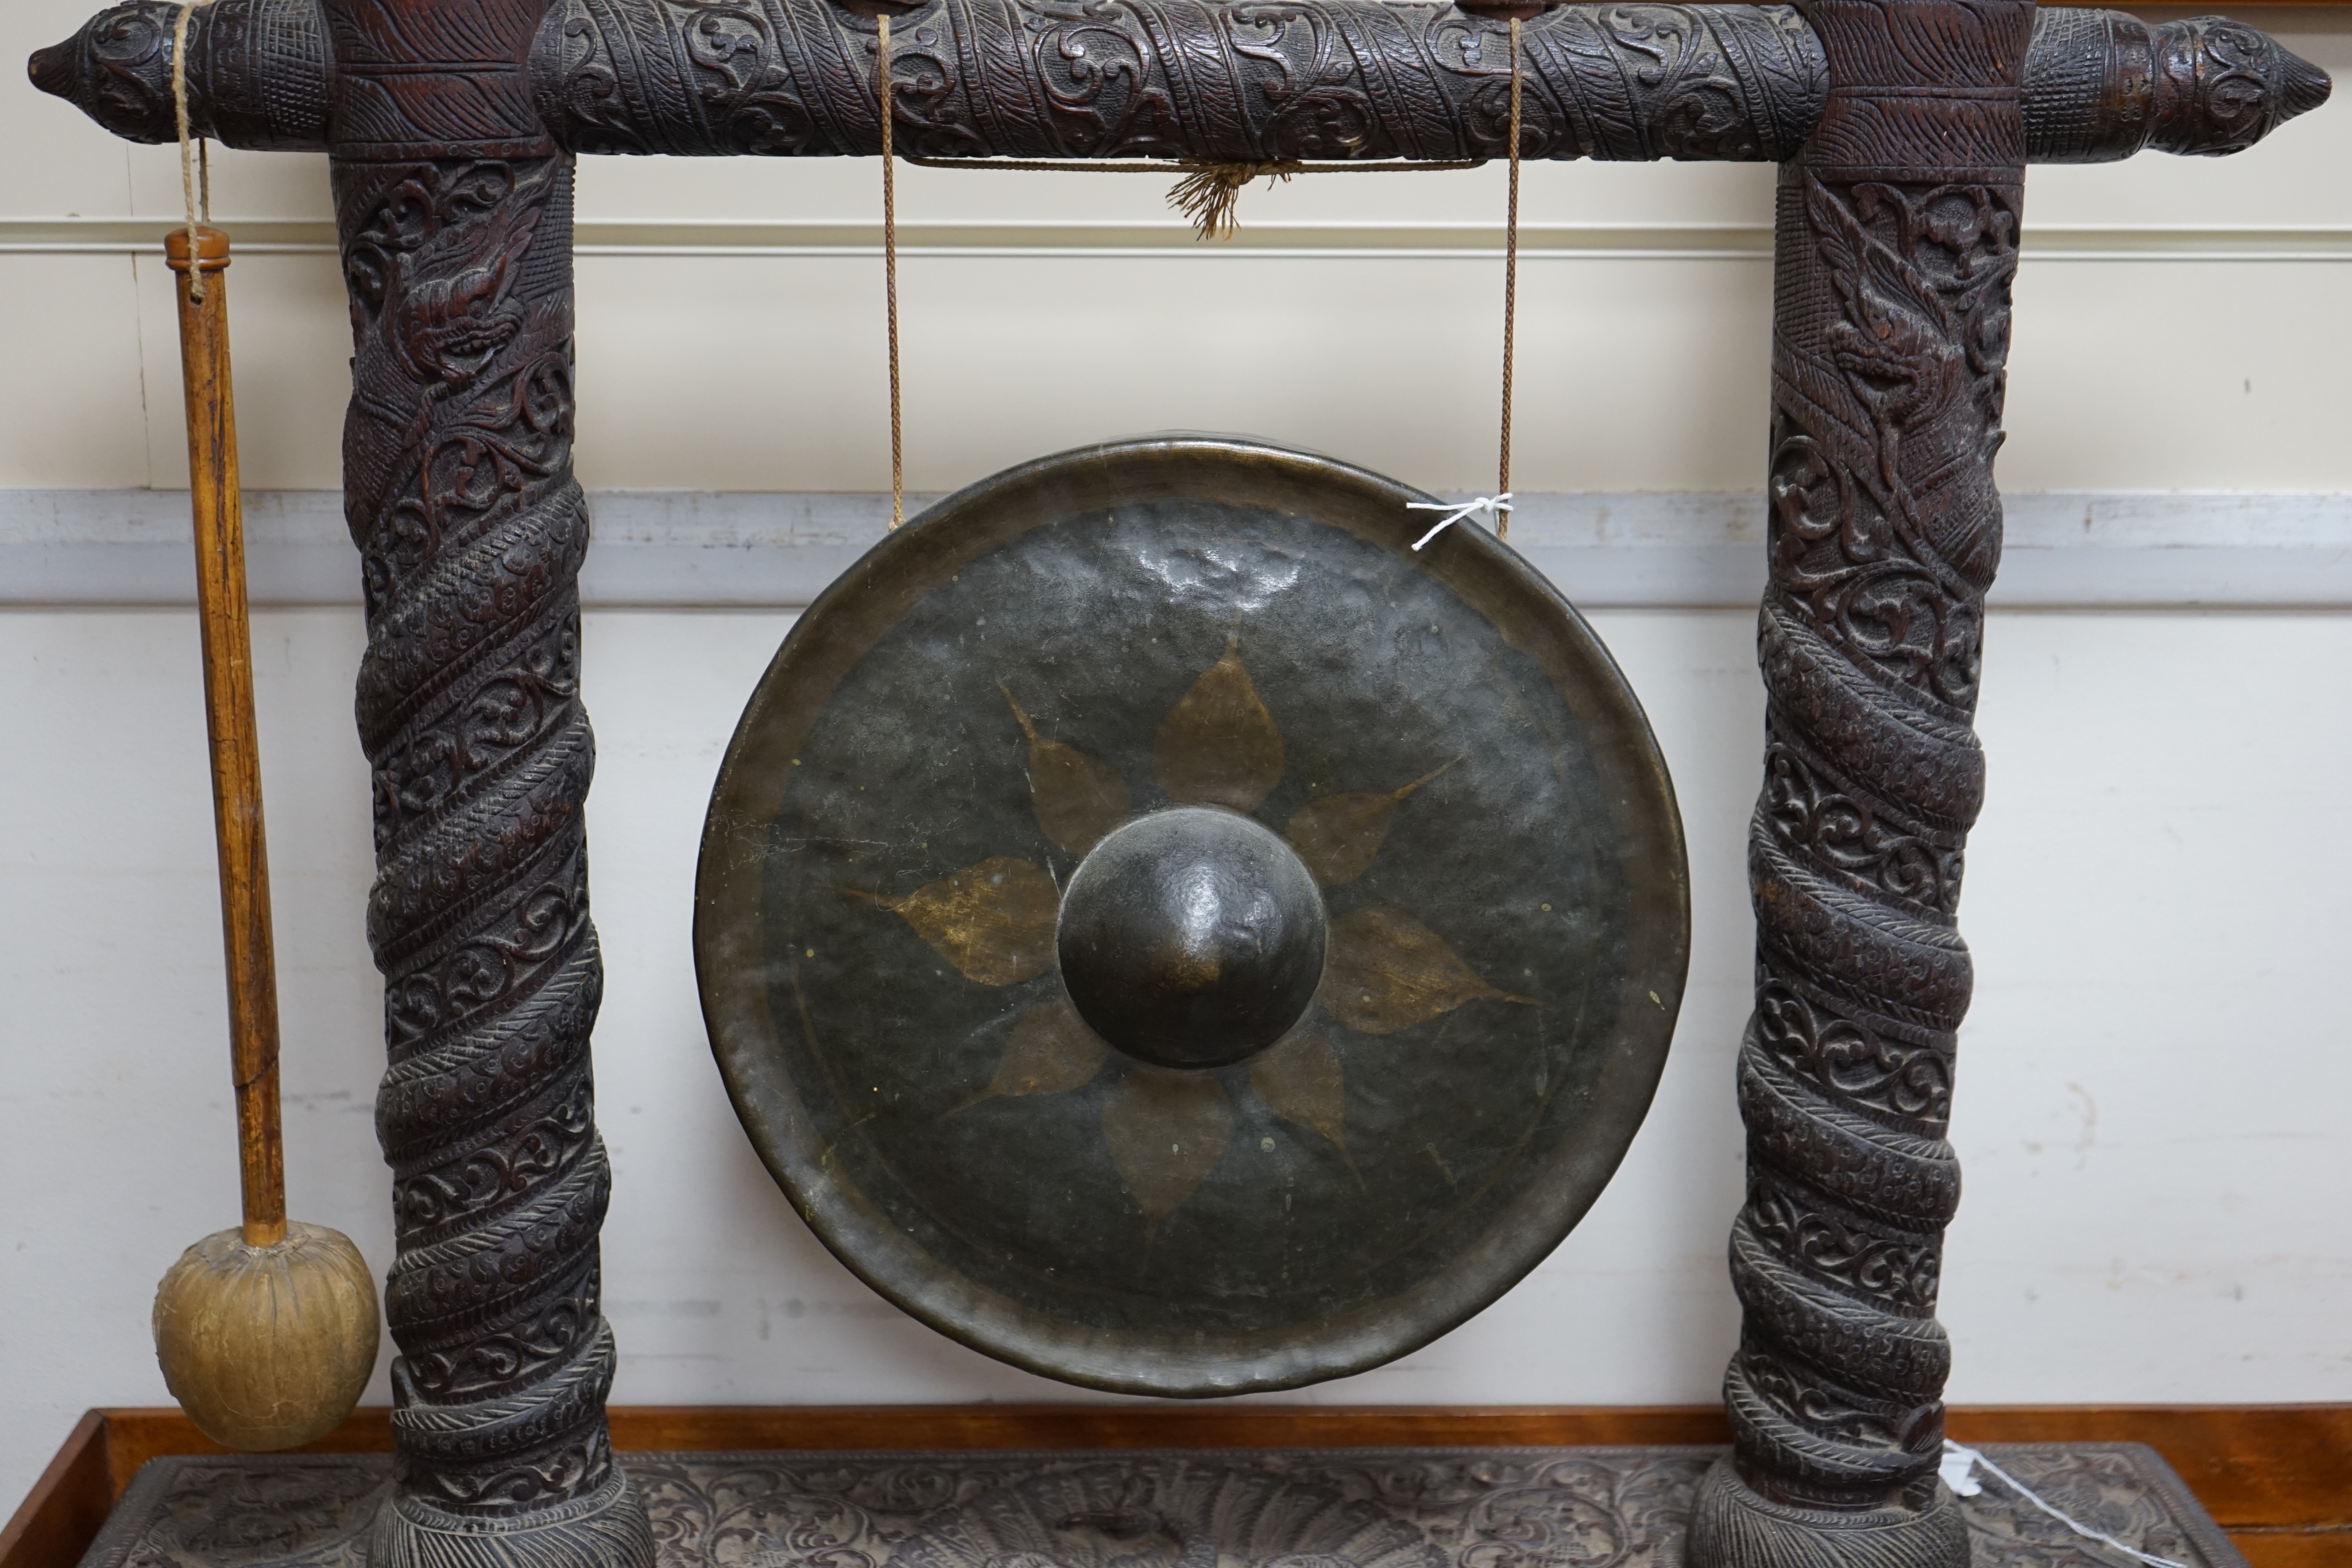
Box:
82, 1443, 2246, 1568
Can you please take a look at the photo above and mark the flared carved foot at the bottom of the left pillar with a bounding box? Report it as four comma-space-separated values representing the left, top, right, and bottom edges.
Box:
372, 1467, 654, 1568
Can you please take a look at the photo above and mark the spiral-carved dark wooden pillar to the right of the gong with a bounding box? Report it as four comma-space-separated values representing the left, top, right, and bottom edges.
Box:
1691, 0, 2034, 1568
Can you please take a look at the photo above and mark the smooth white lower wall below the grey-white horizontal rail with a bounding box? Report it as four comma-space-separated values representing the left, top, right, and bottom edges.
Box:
0, 611, 2352, 1493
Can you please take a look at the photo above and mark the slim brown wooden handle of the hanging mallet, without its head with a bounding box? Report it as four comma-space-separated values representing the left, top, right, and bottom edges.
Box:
165, 226, 287, 1246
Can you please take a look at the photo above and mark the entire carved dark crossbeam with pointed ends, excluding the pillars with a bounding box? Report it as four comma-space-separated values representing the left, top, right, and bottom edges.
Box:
33, 0, 2326, 162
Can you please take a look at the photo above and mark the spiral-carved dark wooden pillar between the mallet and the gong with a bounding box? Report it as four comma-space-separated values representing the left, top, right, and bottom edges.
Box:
324, 0, 652, 1568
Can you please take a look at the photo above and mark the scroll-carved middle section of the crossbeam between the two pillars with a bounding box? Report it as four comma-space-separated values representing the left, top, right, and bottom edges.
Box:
539, 0, 1828, 160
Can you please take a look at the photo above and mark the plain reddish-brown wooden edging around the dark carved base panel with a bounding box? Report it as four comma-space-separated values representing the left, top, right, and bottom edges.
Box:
0, 1403, 2352, 1568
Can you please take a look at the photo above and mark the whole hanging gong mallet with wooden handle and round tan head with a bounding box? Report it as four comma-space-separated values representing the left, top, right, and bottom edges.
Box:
155, 223, 376, 1453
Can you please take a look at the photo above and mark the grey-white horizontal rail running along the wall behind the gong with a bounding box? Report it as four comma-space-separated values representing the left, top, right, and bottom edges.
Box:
0, 489, 2352, 609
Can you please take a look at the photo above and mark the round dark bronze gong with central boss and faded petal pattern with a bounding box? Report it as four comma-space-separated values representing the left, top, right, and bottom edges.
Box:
694, 438, 1689, 1396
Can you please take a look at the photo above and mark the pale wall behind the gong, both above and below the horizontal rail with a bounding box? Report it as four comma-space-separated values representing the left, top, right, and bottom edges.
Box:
0, 0, 2352, 1532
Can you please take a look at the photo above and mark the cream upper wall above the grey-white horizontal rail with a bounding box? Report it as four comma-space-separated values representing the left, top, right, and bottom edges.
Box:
0, 0, 2352, 494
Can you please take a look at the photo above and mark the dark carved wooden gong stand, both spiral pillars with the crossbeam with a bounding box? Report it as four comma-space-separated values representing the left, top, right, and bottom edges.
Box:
30, 0, 2328, 1568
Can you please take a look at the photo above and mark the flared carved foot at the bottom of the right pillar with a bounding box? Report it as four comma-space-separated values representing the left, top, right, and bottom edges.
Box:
1689, 1458, 1971, 1568
